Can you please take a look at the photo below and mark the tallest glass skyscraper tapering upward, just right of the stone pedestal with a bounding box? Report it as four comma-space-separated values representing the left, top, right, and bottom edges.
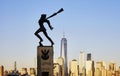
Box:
60, 36, 68, 76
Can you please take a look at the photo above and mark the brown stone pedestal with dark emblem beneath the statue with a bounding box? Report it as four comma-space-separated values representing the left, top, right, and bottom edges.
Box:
37, 46, 53, 76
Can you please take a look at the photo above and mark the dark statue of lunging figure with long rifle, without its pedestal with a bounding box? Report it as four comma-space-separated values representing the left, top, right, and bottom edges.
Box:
34, 8, 63, 46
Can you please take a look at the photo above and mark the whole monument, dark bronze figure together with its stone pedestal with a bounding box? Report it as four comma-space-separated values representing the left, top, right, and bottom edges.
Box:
34, 8, 63, 76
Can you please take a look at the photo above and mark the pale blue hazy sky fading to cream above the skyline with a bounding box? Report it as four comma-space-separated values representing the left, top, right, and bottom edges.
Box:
0, 0, 120, 69
